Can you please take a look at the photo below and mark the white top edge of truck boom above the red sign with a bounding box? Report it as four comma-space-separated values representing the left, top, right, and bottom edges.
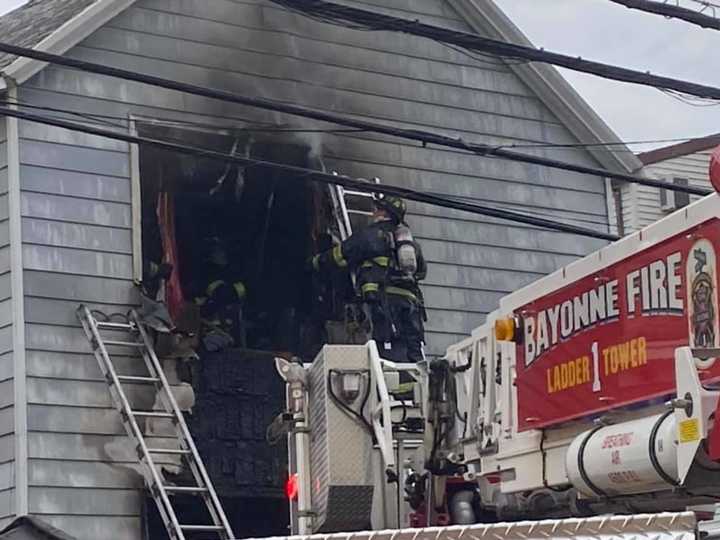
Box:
500, 194, 720, 316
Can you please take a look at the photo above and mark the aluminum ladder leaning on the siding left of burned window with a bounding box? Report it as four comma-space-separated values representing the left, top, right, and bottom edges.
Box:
77, 305, 234, 540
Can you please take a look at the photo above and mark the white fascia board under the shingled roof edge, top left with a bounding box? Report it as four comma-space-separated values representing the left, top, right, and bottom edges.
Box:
0, 0, 135, 85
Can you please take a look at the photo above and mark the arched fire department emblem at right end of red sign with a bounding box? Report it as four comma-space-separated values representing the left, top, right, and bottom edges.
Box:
687, 240, 718, 348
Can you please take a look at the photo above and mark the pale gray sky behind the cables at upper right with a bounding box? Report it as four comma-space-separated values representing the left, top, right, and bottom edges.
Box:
0, 0, 720, 150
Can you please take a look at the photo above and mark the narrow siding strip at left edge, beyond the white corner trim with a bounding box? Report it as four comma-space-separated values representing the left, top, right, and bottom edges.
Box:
0, 116, 15, 523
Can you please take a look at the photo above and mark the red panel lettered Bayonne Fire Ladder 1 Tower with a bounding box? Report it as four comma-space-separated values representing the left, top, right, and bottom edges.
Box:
516, 219, 720, 431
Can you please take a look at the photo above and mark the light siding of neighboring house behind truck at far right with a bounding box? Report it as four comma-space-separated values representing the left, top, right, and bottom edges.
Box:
623, 149, 713, 232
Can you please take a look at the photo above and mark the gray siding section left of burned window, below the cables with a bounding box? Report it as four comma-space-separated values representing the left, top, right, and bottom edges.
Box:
20, 130, 144, 539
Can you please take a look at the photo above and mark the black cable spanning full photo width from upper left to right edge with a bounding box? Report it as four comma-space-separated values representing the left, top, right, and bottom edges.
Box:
0, 40, 708, 196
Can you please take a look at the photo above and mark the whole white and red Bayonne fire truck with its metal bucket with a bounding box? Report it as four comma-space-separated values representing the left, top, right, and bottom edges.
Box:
269, 195, 720, 538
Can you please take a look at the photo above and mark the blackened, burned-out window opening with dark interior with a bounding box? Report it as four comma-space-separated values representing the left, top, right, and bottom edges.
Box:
140, 126, 348, 357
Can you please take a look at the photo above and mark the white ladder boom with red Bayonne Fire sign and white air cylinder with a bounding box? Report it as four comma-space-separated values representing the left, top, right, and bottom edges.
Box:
448, 195, 720, 511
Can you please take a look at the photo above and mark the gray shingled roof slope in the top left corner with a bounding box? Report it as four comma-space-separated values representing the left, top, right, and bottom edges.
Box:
0, 0, 97, 69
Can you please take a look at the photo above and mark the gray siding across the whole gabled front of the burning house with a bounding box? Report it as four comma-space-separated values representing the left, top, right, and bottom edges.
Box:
11, 0, 608, 540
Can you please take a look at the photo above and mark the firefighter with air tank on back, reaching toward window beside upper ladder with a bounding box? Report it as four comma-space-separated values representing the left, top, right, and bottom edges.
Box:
312, 191, 427, 372
